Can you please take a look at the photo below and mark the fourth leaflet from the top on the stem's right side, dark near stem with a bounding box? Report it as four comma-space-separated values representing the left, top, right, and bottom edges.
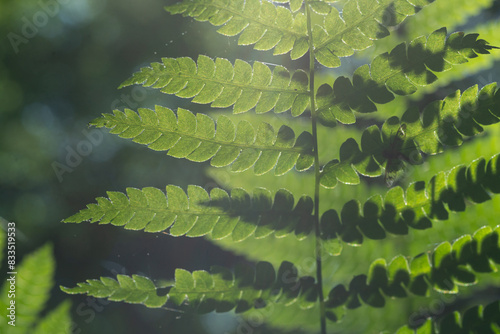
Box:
321, 155, 500, 245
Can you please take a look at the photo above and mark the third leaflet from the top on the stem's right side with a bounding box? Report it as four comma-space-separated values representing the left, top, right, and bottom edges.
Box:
321, 83, 500, 188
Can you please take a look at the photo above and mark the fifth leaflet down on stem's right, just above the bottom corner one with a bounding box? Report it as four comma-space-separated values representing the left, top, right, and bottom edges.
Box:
326, 226, 500, 320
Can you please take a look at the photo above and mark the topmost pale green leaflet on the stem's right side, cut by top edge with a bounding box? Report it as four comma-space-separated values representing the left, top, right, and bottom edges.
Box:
313, 0, 433, 67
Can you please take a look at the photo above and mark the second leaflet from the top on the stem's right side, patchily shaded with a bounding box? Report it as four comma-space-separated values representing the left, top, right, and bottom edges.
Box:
316, 28, 494, 126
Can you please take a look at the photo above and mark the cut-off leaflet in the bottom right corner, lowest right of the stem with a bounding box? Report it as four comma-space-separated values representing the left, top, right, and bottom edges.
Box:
396, 301, 500, 334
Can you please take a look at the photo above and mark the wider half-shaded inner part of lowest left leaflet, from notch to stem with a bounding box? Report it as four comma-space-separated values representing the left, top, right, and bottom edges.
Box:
168, 262, 317, 313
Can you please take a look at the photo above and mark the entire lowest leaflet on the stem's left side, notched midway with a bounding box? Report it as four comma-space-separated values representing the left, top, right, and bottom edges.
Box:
61, 262, 317, 313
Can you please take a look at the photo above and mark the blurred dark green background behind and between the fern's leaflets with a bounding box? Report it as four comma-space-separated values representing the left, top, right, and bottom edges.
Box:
0, 0, 500, 334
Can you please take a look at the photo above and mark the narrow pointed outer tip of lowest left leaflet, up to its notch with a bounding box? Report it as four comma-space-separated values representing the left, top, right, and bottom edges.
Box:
60, 275, 167, 308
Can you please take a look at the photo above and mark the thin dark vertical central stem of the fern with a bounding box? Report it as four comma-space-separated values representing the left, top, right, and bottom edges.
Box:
305, 1, 326, 334
